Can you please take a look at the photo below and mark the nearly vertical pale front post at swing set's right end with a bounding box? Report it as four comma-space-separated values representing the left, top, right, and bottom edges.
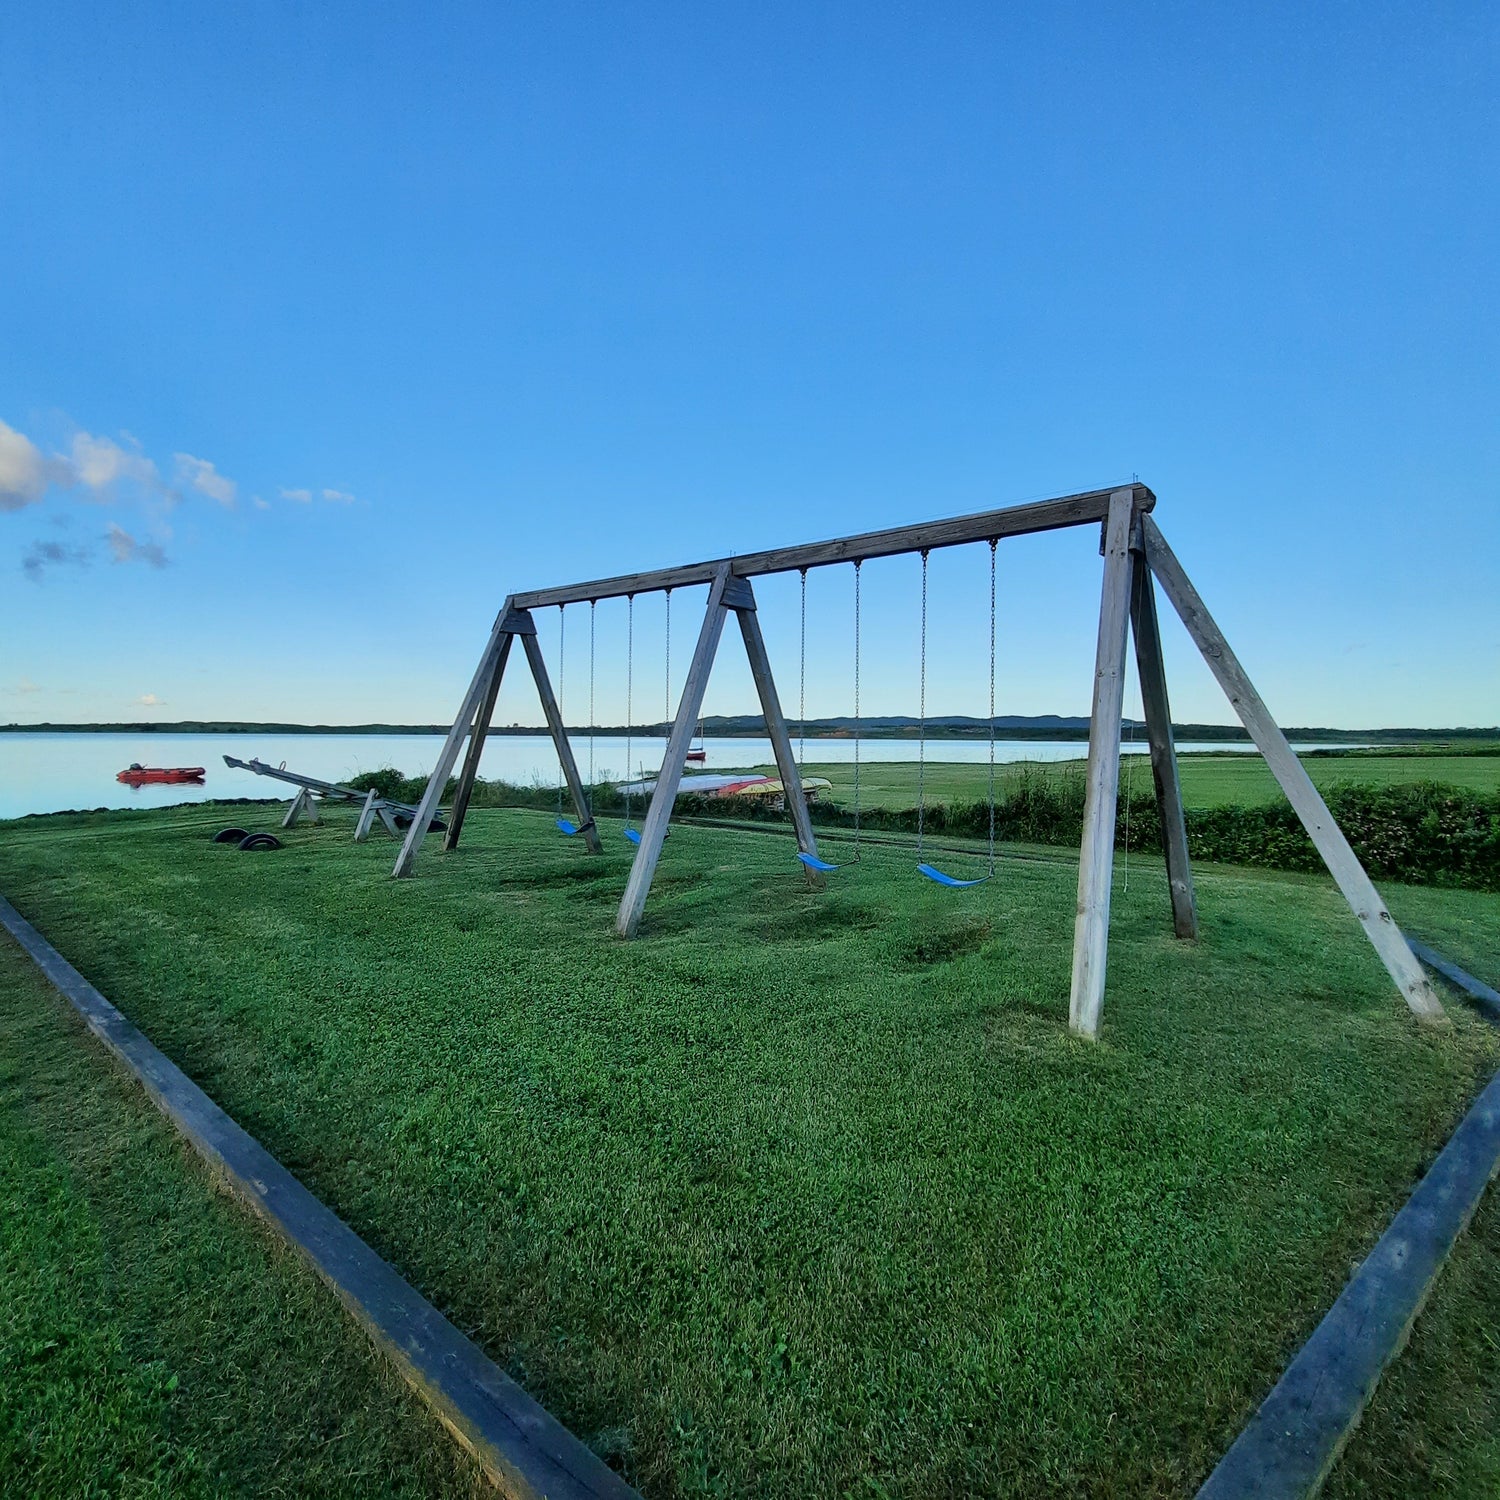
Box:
1068, 489, 1136, 1038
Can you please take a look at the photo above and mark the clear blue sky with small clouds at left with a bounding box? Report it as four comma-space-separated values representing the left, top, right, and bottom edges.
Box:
0, 3, 1500, 726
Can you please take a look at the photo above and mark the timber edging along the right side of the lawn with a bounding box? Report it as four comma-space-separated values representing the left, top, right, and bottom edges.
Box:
1199, 944, 1500, 1500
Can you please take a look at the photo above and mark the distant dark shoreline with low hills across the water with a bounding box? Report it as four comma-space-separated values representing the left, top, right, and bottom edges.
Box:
0, 716, 1500, 746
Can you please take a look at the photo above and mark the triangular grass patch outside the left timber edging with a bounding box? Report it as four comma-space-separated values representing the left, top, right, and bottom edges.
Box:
0, 936, 482, 1497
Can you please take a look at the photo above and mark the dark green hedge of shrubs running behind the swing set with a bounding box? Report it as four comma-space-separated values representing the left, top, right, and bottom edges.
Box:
350, 762, 1500, 891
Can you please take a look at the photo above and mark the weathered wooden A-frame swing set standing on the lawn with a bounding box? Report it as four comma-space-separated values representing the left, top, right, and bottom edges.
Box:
392, 483, 1443, 1038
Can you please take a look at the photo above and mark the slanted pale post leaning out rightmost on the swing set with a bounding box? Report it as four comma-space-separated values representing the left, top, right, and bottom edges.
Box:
1142, 516, 1446, 1022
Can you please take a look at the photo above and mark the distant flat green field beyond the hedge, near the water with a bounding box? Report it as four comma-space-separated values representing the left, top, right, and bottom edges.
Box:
774, 746, 1500, 809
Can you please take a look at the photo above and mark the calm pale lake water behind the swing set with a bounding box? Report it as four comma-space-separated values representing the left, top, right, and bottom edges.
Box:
0, 732, 1350, 818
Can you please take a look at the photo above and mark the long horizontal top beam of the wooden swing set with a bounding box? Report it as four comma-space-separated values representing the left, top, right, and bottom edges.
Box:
515, 485, 1157, 609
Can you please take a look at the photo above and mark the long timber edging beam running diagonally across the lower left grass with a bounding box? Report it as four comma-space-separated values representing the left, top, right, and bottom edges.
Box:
0, 897, 639, 1500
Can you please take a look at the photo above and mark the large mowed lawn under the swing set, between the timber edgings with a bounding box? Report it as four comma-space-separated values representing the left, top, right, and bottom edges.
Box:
0, 807, 1500, 1497
